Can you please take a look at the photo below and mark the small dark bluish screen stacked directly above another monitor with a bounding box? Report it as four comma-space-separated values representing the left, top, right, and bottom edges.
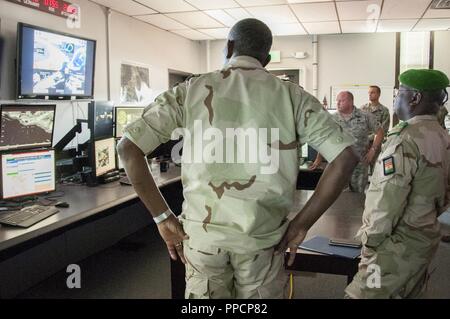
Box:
88, 101, 114, 140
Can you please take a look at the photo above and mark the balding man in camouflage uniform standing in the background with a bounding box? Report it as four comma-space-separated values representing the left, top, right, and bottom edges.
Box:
310, 92, 384, 193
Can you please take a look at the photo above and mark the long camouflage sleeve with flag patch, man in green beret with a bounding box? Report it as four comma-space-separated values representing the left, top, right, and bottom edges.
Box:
359, 136, 419, 248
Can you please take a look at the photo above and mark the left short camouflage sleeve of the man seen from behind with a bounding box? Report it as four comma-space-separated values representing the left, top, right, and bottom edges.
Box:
124, 83, 186, 154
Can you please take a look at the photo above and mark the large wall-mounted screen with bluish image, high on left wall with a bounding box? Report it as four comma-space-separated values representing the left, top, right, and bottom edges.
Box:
17, 23, 96, 99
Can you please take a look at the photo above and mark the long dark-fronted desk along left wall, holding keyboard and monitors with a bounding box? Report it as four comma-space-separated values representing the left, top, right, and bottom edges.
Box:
0, 167, 183, 298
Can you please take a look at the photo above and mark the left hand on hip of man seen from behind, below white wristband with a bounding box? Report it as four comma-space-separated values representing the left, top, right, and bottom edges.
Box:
157, 215, 189, 264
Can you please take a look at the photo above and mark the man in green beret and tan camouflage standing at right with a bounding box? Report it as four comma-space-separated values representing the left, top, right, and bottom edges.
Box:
345, 70, 450, 298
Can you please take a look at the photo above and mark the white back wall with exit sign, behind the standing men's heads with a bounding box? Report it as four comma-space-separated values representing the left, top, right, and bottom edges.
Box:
206, 33, 395, 103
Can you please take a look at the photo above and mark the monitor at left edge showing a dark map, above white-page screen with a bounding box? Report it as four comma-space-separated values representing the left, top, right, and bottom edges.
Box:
0, 105, 56, 151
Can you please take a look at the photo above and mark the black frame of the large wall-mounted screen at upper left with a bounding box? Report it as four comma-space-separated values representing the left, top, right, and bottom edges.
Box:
16, 22, 97, 100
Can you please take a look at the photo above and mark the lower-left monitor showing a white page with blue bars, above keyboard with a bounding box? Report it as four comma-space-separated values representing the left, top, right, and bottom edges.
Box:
0, 150, 56, 199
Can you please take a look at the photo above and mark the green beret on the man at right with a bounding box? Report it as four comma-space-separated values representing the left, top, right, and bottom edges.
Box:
399, 70, 450, 91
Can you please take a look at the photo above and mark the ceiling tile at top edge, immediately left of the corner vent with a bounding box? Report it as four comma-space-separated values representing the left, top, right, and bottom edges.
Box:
381, 0, 431, 20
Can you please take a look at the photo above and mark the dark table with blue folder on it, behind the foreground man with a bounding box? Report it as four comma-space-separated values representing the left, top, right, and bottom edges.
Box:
171, 190, 364, 299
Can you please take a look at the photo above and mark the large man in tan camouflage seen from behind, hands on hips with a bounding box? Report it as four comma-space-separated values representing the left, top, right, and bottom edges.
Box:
118, 19, 357, 299
